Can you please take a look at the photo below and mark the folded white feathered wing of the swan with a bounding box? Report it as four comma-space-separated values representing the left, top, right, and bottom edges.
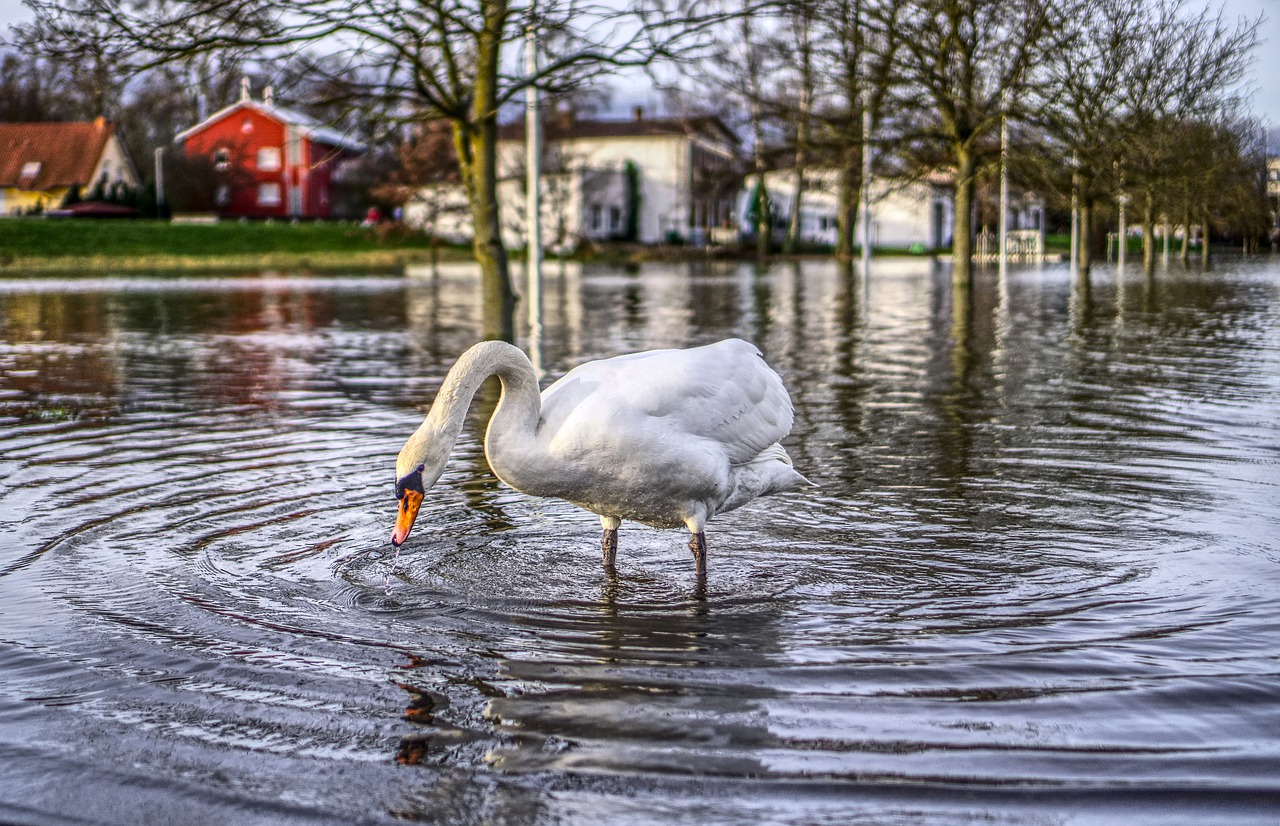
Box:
543, 339, 794, 464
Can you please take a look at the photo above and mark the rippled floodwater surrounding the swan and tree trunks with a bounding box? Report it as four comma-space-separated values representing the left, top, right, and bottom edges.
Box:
0, 259, 1280, 826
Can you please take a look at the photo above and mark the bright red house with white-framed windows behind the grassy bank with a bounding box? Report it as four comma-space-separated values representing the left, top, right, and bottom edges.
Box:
175, 78, 365, 218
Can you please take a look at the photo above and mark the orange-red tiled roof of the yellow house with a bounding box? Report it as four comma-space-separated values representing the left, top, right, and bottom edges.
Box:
0, 118, 114, 191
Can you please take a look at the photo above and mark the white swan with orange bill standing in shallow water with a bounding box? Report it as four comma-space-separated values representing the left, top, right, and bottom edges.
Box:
392, 339, 806, 578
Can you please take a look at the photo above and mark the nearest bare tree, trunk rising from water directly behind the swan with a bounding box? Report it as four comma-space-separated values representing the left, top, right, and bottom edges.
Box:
12, 0, 721, 338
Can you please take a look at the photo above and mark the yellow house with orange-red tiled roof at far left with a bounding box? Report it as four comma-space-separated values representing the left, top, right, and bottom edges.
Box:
0, 118, 138, 216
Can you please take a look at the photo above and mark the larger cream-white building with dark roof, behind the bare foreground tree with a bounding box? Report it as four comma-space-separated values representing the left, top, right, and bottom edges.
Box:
404, 109, 740, 248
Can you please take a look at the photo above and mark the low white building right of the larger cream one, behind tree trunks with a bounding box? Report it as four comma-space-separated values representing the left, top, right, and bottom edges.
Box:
737, 168, 955, 250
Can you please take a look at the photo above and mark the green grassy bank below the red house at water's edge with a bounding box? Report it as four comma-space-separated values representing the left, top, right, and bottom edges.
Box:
0, 218, 471, 274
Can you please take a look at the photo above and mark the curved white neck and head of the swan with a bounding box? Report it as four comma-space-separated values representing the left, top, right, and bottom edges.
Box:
396, 342, 541, 487
